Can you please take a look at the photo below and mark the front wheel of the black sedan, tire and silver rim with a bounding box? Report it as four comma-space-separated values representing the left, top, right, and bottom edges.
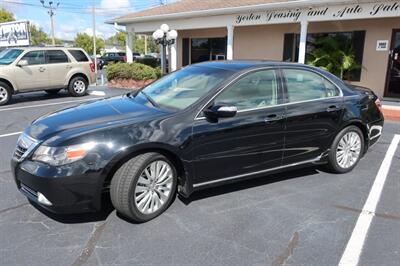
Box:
110, 152, 177, 223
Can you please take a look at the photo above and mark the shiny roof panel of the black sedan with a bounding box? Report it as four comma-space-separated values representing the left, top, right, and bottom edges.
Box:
195, 60, 312, 71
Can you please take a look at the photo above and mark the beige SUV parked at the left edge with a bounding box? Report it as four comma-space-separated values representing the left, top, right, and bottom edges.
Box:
0, 47, 96, 105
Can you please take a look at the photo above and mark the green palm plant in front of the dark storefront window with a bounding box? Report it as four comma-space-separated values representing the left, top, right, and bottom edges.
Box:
307, 34, 361, 79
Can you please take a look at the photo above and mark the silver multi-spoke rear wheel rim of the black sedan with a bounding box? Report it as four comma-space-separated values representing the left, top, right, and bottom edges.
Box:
336, 131, 362, 169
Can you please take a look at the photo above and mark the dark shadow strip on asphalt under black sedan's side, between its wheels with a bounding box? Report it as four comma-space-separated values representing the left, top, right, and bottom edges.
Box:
179, 166, 322, 205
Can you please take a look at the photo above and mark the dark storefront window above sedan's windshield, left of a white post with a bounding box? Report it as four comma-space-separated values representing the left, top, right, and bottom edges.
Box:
191, 38, 226, 64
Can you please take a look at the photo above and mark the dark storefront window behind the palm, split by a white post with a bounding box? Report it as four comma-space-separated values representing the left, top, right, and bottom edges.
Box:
283, 31, 365, 81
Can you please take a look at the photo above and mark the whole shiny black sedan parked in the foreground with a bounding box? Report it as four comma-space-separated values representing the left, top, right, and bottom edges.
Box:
12, 61, 384, 222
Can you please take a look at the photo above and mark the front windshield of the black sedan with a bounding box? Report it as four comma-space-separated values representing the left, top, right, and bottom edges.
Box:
138, 66, 233, 110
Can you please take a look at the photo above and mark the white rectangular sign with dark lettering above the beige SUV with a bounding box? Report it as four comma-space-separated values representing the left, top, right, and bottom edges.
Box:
0, 21, 30, 47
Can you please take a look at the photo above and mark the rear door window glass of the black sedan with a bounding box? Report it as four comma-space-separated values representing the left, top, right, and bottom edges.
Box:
283, 69, 340, 103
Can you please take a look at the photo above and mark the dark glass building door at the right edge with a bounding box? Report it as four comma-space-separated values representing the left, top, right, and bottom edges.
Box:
385, 29, 400, 98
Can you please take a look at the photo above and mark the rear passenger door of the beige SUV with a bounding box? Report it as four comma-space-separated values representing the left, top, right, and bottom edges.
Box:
46, 50, 72, 88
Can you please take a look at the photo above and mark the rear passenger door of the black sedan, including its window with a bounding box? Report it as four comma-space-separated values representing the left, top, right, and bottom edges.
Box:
282, 68, 343, 165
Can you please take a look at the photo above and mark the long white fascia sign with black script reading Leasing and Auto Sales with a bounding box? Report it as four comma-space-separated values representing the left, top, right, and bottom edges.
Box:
235, 1, 400, 25
